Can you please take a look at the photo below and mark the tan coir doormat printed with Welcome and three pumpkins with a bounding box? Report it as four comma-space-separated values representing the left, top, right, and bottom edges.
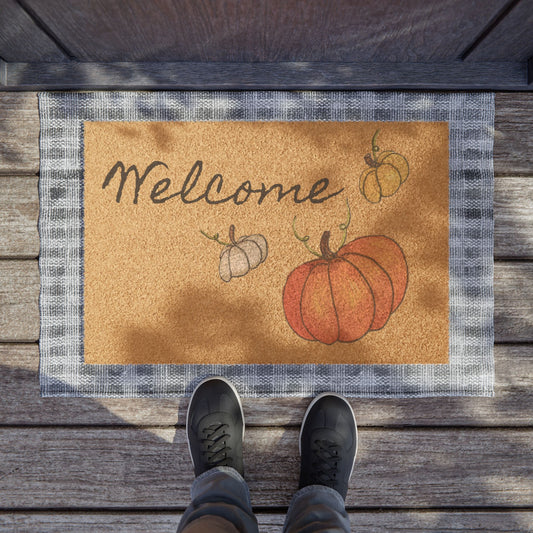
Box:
84, 122, 449, 364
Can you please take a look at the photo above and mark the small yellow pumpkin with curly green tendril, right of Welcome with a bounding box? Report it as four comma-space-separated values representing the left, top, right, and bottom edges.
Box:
359, 130, 409, 204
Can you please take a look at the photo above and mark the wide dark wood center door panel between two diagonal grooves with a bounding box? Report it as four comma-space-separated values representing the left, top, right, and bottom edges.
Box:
18, 0, 505, 62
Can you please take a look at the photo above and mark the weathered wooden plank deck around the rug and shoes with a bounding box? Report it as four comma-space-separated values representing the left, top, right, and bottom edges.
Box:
0, 92, 533, 533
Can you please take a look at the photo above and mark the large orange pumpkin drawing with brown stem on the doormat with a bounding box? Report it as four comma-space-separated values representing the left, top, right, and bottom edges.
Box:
283, 231, 408, 344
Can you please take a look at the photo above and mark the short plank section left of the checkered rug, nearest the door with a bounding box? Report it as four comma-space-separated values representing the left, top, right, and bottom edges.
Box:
0, 93, 39, 174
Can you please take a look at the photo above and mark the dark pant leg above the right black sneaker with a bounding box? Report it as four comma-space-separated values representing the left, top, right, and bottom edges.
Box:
283, 485, 350, 533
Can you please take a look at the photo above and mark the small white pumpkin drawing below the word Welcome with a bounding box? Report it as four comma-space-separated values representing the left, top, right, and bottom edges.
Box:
202, 224, 268, 282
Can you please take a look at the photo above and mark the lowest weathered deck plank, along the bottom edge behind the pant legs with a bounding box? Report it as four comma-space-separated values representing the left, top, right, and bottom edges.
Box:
0, 510, 533, 533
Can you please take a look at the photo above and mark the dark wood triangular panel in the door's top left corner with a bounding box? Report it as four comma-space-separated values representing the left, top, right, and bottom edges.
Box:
0, 0, 65, 62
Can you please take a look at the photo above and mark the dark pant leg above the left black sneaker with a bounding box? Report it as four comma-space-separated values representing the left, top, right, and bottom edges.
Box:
178, 466, 259, 533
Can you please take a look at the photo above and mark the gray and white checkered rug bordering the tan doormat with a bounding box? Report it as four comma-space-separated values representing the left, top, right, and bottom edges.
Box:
39, 91, 494, 397
